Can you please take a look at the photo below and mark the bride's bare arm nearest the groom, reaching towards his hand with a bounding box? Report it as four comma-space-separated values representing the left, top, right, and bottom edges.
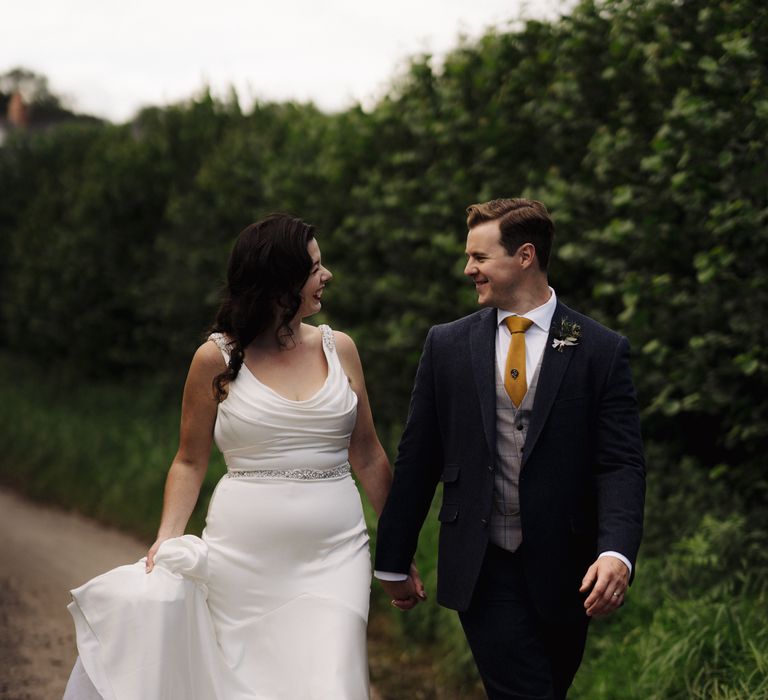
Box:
334, 331, 392, 515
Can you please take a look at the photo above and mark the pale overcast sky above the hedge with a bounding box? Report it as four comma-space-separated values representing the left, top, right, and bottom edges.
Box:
0, 0, 573, 121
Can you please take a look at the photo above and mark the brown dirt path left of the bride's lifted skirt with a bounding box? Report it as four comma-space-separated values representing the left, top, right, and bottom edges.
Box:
0, 489, 146, 700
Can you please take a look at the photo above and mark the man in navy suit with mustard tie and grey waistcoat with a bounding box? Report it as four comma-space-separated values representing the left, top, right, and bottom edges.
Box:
376, 199, 645, 699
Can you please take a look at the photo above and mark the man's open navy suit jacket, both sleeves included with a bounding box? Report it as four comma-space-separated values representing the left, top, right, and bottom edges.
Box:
376, 302, 645, 619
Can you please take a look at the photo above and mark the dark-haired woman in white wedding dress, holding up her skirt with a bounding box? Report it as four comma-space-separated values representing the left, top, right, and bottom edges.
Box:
64, 214, 421, 700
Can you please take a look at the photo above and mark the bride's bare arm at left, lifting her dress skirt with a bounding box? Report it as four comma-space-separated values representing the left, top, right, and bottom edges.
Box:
147, 341, 225, 573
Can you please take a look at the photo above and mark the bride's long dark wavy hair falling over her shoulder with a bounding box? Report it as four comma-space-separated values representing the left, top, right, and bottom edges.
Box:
208, 213, 315, 401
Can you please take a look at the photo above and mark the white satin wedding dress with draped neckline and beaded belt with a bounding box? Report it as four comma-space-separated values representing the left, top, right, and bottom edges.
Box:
64, 326, 371, 700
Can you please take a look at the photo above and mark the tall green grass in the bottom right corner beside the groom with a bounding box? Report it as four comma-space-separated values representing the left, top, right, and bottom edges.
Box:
571, 589, 768, 700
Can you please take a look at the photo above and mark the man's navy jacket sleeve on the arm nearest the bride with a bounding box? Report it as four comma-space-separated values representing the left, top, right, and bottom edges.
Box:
375, 328, 442, 573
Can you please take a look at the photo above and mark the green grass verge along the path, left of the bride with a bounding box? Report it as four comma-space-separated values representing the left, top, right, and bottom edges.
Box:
0, 358, 223, 541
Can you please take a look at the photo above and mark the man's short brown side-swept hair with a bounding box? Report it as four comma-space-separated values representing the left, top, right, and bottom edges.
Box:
467, 198, 555, 272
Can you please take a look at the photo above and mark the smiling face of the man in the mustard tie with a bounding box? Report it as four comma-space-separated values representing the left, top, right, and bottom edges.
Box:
464, 221, 521, 310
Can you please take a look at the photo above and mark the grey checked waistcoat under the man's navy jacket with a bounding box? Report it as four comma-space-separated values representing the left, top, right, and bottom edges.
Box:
489, 353, 544, 552
